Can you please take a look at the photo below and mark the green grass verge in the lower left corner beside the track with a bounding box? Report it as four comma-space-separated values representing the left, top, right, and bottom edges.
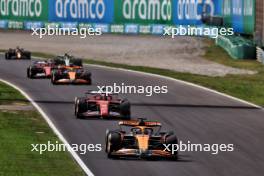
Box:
0, 83, 84, 176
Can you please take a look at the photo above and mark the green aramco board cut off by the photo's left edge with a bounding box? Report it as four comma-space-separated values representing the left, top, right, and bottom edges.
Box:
0, 0, 48, 21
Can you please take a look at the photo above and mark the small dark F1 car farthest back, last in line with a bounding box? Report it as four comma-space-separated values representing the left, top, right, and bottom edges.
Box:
5, 47, 31, 60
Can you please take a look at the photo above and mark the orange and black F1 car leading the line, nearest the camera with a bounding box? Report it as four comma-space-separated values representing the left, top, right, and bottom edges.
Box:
105, 118, 178, 160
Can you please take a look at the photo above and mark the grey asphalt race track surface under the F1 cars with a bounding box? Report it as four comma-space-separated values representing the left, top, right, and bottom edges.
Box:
0, 55, 264, 176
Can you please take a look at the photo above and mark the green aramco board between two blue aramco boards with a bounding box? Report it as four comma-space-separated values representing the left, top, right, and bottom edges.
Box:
114, 0, 173, 24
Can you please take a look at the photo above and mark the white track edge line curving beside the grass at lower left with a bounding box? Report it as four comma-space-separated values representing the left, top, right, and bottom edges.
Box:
0, 78, 94, 176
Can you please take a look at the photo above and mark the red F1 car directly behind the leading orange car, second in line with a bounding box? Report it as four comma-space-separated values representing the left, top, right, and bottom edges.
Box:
75, 92, 131, 119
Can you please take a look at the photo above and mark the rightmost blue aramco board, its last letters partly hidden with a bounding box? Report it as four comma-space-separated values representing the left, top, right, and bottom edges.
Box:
173, 0, 222, 25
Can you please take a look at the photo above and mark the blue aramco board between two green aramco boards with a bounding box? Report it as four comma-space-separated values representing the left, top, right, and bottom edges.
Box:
49, 0, 114, 23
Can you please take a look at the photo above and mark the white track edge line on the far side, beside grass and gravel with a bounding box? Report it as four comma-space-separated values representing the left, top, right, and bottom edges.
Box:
85, 64, 263, 109
